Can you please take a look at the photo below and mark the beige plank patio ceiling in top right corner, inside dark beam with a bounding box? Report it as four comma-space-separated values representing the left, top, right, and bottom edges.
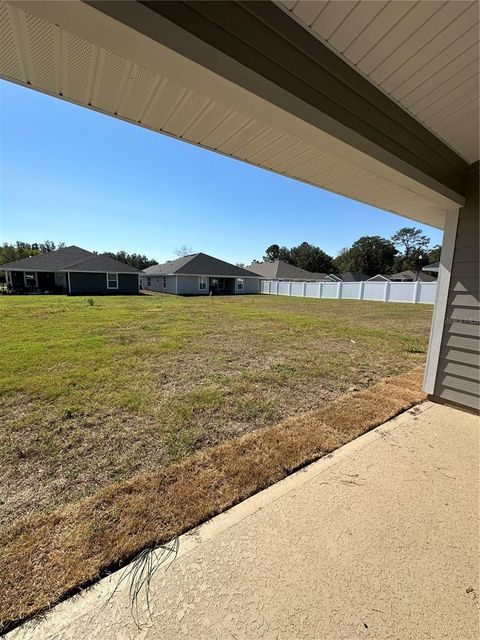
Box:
277, 0, 480, 162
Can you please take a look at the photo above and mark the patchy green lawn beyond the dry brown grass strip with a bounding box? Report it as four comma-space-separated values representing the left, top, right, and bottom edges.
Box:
0, 295, 432, 527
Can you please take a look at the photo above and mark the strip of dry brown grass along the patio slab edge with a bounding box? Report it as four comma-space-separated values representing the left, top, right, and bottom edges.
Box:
0, 368, 425, 629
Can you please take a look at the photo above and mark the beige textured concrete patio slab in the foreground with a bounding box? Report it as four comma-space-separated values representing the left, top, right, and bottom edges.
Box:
9, 402, 480, 640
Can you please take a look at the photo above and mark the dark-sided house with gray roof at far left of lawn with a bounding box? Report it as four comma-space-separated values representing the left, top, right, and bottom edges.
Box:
0, 245, 140, 295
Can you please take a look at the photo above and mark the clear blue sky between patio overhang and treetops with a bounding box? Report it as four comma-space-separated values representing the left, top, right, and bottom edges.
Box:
0, 81, 442, 263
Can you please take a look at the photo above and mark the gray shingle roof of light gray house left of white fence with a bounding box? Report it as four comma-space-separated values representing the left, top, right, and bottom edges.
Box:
143, 253, 258, 278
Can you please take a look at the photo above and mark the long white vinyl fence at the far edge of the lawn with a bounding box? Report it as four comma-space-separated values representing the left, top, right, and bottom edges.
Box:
260, 280, 437, 304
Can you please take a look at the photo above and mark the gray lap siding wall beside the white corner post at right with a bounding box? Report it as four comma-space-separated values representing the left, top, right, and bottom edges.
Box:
434, 165, 480, 410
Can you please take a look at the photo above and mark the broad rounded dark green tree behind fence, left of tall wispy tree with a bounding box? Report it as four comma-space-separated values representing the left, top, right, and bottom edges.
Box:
334, 236, 398, 276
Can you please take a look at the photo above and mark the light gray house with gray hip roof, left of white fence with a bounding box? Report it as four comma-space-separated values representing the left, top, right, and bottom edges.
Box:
140, 253, 260, 295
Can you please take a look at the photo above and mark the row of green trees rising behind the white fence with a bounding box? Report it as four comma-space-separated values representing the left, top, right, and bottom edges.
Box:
260, 227, 441, 276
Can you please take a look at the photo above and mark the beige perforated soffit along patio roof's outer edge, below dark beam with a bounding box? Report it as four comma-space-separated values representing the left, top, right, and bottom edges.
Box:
0, 2, 462, 228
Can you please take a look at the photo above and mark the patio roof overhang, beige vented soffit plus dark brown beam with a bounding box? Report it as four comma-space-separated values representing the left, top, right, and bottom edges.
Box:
0, 0, 476, 228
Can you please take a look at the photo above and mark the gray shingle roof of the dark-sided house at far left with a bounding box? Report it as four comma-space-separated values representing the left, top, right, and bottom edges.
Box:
0, 245, 139, 273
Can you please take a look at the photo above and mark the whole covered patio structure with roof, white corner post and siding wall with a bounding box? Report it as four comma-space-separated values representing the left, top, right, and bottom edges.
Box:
0, 0, 480, 409
